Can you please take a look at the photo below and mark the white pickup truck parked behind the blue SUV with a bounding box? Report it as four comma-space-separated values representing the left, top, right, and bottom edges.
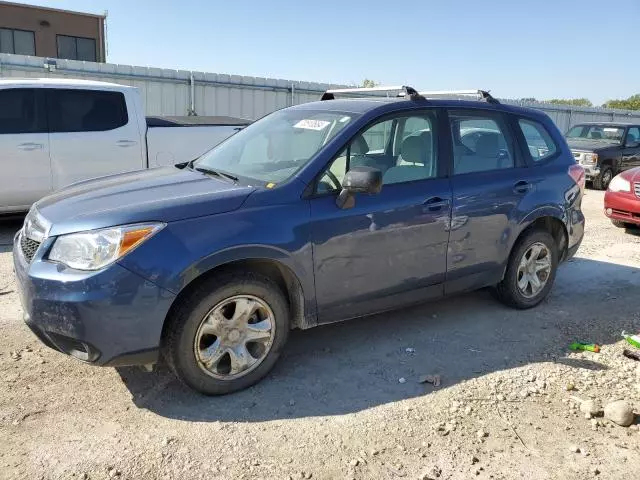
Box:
0, 78, 249, 214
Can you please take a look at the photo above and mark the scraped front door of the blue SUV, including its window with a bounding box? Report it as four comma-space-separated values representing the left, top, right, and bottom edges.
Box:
310, 111, 451, 323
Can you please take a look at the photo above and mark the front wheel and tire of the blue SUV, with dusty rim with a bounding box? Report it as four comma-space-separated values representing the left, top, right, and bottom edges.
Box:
162, 271, 290, 395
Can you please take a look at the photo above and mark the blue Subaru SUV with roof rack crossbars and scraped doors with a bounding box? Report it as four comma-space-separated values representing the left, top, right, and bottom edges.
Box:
13, 87, 585, 394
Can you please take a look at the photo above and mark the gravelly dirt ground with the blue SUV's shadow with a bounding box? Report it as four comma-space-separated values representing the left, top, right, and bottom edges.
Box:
0, 190, 640, 479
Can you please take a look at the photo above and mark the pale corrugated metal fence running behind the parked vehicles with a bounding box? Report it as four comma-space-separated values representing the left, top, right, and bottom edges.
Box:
0, 54, 640, 132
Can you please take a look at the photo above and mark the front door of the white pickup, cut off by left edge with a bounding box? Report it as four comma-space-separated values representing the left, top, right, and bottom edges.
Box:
0, 88, 51, 211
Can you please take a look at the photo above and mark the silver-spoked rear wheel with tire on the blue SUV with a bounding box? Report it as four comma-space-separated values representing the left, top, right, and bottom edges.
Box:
495, 230, 558, 309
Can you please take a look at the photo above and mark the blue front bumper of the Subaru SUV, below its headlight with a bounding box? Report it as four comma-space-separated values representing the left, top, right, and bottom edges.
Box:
13, 233, 175, 366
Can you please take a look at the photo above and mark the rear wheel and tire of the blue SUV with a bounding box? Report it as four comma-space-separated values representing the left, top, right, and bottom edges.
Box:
495, 230, 559, 310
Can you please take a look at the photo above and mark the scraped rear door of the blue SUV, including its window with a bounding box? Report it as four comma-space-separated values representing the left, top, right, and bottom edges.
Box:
445, 109, 532, 293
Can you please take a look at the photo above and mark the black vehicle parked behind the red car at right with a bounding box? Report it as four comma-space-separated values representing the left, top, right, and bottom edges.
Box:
566, 122, 640, 190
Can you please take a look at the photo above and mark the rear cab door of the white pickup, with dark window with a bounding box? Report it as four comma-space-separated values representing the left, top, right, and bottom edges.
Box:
47, 89, 144, 190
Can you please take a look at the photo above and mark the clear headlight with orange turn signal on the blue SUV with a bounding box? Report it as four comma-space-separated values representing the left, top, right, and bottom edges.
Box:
48, 223, 165, 270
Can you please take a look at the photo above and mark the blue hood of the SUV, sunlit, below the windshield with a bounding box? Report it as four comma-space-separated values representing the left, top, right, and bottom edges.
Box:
35, 167, 255, 235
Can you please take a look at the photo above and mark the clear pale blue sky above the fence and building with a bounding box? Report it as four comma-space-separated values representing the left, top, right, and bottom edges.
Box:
13, 0, 640, 105
